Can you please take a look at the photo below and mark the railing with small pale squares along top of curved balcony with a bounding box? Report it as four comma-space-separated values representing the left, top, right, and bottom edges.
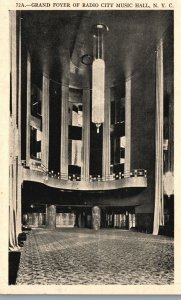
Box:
22, 161, 147, 182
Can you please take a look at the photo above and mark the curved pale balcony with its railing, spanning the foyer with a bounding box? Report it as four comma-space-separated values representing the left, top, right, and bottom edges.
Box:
22, 162, 147, 191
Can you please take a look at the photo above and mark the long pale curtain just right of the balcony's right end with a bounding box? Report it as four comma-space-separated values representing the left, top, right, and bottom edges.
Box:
153, 40, 164, 235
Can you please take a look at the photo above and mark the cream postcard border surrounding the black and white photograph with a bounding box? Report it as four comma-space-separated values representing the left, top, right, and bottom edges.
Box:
0, 0, 181, 295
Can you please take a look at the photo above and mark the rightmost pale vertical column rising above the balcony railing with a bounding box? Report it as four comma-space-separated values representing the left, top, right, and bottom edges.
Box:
125, 79, 131, 172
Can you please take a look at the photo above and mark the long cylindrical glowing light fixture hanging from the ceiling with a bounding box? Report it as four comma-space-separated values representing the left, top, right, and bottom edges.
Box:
92, 24, 108, 133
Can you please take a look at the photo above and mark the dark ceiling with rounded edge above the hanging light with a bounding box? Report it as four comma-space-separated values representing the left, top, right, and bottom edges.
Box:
21, 11, 173, 85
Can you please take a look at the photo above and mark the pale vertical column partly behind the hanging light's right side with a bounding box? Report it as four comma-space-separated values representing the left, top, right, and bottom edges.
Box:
102, 88, 111, 179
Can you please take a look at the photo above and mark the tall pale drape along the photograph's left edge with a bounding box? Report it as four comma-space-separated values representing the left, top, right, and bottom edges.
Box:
9, 11, 21, 251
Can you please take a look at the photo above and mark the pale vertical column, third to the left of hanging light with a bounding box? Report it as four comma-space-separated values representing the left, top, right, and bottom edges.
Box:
41, 75, 49, 169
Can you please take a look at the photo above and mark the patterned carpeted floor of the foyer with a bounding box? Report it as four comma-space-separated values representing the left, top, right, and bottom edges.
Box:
16, 228, 174, 285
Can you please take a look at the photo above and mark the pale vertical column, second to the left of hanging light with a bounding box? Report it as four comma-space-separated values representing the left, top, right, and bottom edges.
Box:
60, 85, 69, 179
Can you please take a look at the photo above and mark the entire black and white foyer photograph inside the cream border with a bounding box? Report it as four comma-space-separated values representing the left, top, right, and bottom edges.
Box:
7, 8, 174, 286
